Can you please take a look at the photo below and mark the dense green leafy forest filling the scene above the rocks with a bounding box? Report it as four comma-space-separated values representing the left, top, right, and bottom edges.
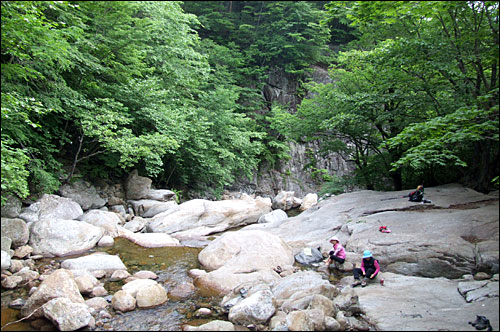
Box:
1, 1, 500, 204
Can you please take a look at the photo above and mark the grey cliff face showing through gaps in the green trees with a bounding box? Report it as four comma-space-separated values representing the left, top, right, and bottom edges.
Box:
229, 66, 355, 197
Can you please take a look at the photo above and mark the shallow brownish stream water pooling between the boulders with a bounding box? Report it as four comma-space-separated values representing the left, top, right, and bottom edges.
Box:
2, 238, 227, 331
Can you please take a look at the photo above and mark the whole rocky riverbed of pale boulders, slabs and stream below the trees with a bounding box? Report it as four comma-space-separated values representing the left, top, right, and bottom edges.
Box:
2, 174, 499, 331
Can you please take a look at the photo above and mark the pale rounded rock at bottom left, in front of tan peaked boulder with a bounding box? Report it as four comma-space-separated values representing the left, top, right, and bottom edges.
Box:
42, 297, 92, 331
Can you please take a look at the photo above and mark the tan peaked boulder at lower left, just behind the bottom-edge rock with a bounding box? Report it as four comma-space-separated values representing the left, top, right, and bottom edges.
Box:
21, 269, 85, 318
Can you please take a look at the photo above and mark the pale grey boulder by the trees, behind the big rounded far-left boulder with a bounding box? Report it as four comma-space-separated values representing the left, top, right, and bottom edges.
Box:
19, 194, 83, 222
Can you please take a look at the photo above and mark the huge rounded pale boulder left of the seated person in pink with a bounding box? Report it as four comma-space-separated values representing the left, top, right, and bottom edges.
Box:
195, 231, 294, 295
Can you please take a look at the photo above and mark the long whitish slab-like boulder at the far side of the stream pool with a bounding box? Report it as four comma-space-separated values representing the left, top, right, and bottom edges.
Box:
147, 196, 271, 239
